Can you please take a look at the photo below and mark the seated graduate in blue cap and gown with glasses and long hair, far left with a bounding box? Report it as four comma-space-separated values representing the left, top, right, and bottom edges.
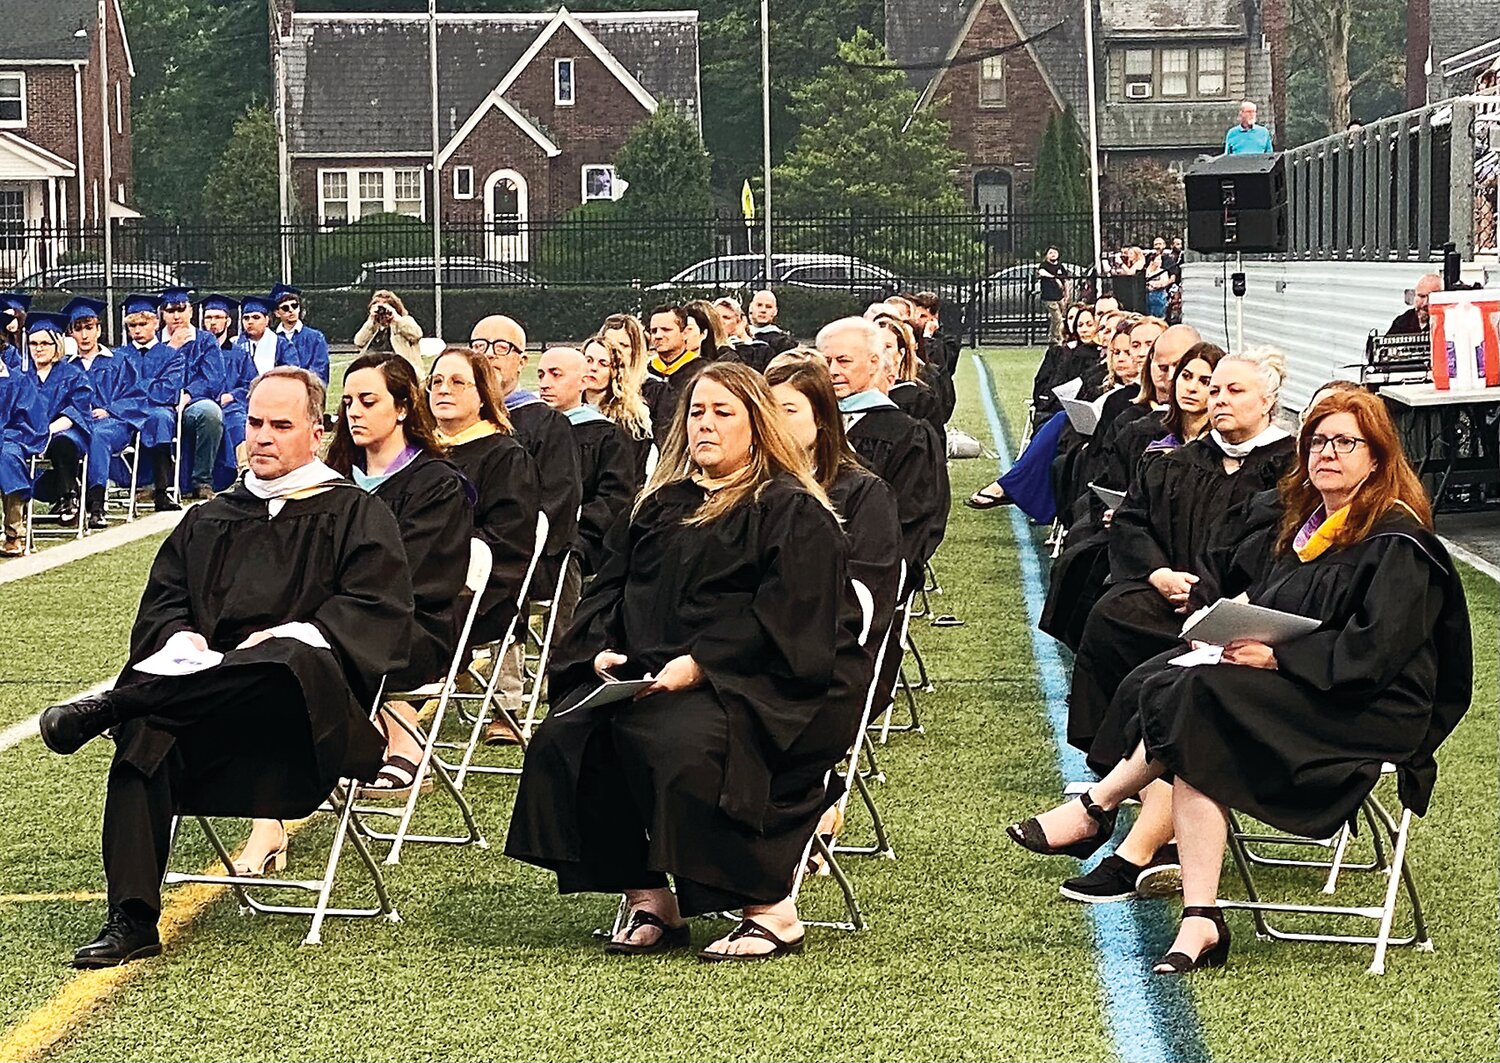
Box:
26, 313, 95, 523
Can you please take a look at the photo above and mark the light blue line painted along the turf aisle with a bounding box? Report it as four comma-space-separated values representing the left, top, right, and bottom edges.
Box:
974, 354, 1211, 1063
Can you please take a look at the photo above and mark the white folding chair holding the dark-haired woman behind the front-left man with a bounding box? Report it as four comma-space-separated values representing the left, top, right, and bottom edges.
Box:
360, 538, 494, 864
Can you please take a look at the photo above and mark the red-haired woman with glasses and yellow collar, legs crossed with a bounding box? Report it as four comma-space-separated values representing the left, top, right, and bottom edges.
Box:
1008, 391, 1473, 975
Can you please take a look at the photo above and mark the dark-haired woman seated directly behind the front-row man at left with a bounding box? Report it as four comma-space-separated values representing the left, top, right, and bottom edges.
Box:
329, 354, 474, 793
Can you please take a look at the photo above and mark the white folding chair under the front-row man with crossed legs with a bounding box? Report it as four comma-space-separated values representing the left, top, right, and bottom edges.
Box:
162, 679, 401, 945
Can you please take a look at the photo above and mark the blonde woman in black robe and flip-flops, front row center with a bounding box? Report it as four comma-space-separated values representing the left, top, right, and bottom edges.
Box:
506, 363, 870, 960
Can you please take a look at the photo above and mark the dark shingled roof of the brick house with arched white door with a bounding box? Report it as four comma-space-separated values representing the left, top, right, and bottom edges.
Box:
284, 9, 701, 154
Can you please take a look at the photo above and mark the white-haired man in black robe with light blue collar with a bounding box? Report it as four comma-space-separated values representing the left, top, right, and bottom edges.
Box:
818, 318, 950, 598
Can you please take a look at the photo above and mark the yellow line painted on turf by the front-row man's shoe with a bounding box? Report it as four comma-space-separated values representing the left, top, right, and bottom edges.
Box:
0, 820, 308, 1063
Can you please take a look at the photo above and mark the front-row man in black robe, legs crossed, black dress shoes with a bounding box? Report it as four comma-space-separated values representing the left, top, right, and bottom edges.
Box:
41, 367, 413, 967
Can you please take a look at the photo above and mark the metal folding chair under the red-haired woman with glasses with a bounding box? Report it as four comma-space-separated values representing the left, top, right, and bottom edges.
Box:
1218, 765, 1433, 975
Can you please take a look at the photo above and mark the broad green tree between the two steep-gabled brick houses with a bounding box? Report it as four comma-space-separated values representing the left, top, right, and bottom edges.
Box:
773, 30, 963, 214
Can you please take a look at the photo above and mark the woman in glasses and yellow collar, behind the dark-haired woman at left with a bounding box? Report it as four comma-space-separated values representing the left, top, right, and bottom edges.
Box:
428, 348, 542, 646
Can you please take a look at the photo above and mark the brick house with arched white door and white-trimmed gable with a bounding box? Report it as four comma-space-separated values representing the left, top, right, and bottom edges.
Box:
273, 0, 702, 261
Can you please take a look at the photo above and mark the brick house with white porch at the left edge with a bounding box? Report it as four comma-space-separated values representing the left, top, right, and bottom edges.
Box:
0, 0, 135, 273
